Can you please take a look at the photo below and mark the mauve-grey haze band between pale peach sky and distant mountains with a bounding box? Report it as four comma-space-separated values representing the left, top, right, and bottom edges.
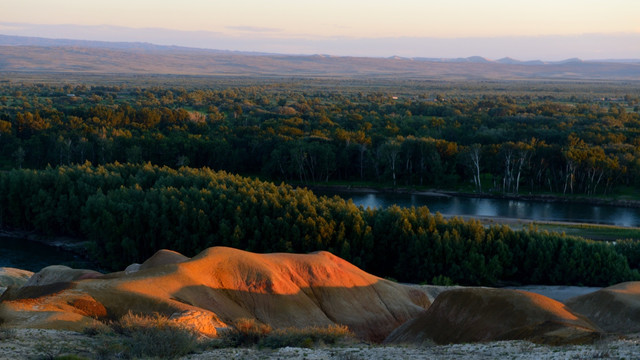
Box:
0, 22, 640, 62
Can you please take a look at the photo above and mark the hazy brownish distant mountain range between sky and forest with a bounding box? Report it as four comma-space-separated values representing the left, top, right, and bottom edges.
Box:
0, 35, 640, 80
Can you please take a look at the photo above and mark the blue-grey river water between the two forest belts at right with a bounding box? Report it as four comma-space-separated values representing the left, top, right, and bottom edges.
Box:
314, 190, 640, 227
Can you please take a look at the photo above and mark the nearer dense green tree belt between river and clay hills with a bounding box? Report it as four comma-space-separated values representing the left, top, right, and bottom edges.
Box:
0, 163, 640, 286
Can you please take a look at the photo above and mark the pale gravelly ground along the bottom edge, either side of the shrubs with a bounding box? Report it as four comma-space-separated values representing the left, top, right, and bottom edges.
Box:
0, 329, 640, 360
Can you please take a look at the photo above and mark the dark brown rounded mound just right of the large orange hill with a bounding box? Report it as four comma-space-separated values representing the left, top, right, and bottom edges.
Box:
385, 288, 600, 344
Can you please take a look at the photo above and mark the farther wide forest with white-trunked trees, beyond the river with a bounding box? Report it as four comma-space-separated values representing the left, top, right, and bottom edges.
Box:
0, 80, 640, 195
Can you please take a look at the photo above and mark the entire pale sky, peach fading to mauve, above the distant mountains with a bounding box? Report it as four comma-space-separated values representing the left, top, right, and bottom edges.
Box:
0, 0, 640, 60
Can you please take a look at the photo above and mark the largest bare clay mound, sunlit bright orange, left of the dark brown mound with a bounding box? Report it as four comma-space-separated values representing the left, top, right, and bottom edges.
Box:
0, 247, 430, 341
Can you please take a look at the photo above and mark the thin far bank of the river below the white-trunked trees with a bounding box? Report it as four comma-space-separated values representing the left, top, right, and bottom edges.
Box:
304, 184, 640, 208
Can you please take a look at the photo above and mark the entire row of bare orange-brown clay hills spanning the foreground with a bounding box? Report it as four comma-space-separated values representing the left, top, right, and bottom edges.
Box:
0, 247, 640, 344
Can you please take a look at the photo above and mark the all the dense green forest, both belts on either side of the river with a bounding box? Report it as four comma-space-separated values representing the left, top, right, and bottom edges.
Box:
0, 78, 640, 286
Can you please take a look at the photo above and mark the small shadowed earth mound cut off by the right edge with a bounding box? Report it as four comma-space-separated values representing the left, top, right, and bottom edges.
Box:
566, 281, 640, 333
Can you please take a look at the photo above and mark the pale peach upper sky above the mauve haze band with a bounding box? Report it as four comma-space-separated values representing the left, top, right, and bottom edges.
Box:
0, 0, 640, 57
